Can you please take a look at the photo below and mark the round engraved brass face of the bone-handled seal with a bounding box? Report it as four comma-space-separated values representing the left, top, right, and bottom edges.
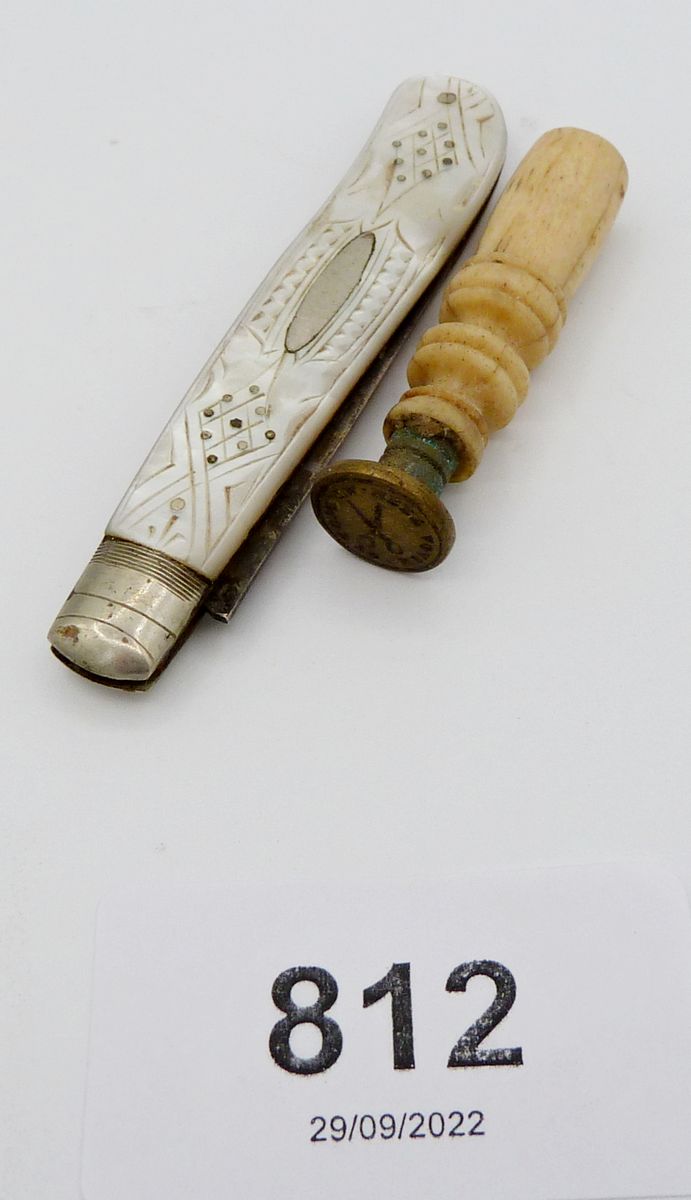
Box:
312, 462, 455, 571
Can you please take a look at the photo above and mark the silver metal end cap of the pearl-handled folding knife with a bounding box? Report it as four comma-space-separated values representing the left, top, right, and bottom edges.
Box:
48, 538, 210, 685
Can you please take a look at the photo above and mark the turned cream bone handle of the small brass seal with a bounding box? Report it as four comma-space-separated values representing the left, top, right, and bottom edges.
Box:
384, 128, 627, 481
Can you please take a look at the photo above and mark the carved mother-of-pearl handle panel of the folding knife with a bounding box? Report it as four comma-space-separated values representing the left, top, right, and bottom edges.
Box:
107, 76, 505, 580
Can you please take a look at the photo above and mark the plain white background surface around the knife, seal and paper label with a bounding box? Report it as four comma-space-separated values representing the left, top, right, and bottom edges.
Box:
0, 0, 691, 1200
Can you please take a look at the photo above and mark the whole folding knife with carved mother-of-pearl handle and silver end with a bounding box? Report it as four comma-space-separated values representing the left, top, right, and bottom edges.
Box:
48, 76, 506, 688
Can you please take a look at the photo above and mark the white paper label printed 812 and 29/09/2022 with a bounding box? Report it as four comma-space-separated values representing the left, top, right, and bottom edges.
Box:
83, 866, 691, 1200
